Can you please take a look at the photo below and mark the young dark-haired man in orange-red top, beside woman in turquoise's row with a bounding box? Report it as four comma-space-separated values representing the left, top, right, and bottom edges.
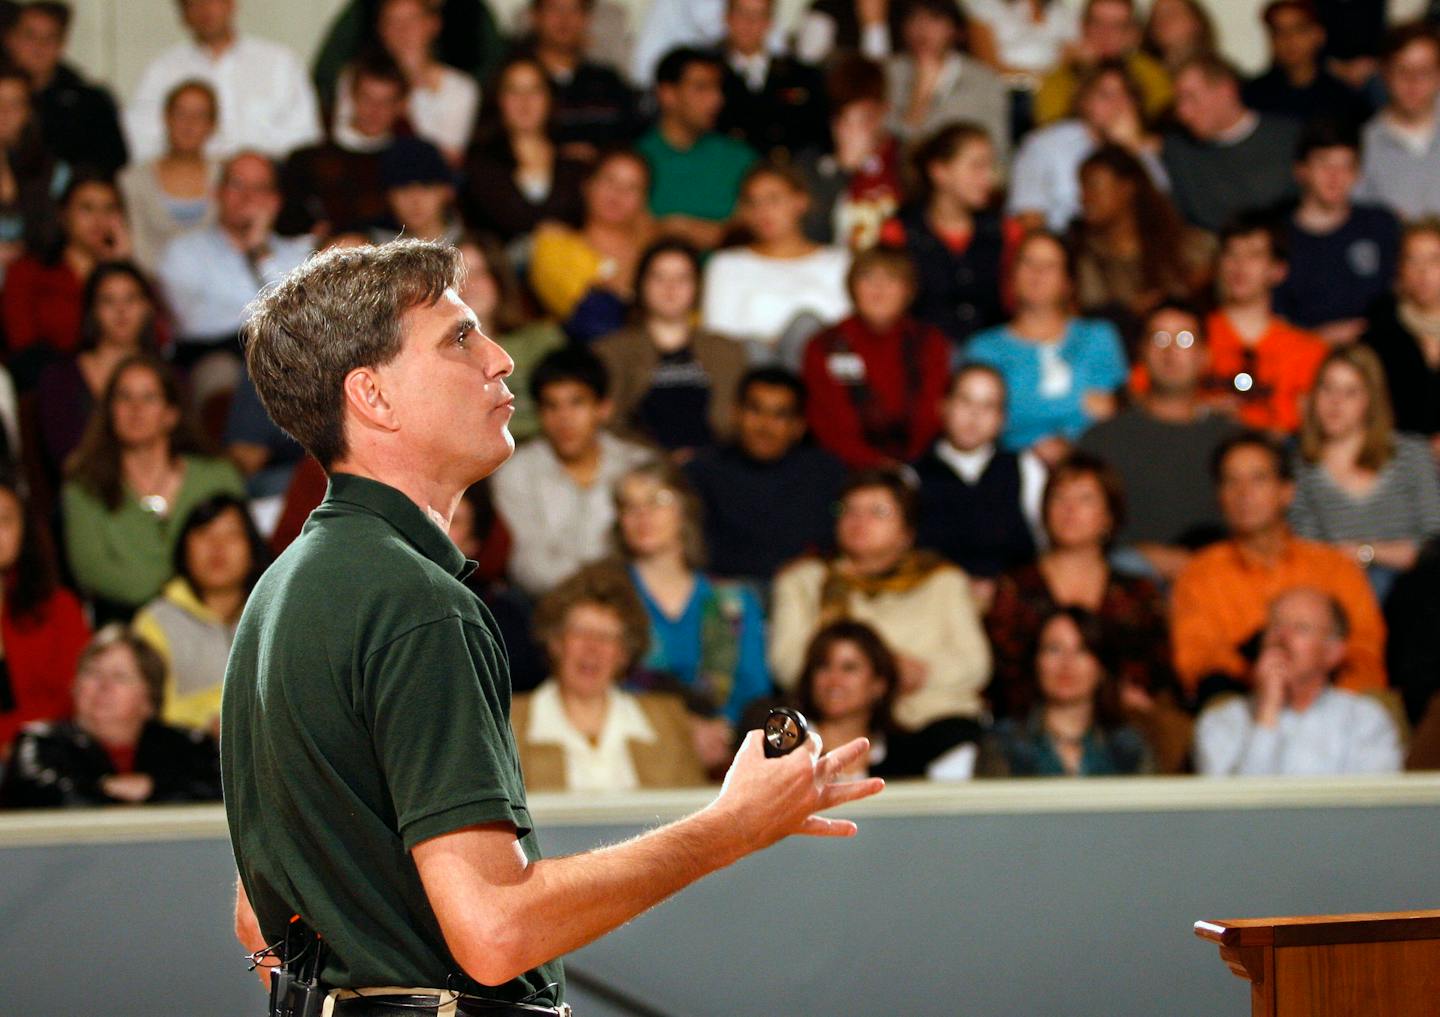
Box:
1205, 213, 1326, 434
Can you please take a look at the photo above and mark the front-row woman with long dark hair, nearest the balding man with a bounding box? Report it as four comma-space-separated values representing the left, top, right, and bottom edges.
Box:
979, 606, 1153, 776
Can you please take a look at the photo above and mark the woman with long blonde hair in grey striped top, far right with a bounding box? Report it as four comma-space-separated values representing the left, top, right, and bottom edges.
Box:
1290, 346, 1440, 599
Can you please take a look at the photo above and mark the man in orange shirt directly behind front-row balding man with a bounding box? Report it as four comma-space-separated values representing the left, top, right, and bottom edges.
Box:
1171, 432, 1385, 700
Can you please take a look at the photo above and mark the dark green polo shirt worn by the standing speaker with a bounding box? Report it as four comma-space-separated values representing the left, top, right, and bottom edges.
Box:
220, 474, 564, 1003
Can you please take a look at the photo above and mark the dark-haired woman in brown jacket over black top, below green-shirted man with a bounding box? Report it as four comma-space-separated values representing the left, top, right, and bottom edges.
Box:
595, 239, 744, 460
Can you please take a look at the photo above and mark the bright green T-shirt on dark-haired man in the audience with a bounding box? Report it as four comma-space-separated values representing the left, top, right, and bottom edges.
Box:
635, 127, 756, 222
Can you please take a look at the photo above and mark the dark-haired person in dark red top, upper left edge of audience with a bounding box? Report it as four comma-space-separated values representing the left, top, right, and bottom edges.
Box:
0, 174, 131, 374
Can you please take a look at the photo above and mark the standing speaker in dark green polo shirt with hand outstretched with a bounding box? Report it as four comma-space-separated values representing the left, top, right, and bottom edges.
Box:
220, 241, 881, 1017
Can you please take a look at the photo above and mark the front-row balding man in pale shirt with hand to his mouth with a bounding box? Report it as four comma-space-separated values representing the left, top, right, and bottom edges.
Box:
1195, 588, 1403, 776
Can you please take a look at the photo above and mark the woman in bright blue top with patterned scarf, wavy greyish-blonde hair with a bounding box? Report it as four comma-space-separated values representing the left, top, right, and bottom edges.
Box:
615, 462, 770, 768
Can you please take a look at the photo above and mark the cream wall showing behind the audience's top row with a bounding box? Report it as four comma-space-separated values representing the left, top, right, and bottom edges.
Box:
71, 0, 1424, 105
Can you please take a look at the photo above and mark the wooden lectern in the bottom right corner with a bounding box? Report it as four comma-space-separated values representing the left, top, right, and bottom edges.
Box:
1195, 910, 1440, 1017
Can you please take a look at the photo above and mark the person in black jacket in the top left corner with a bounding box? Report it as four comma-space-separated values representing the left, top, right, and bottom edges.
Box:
4, 0, 128, 174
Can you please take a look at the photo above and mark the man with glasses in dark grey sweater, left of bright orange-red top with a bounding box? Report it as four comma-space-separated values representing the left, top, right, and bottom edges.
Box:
1079, 301, 1236, 582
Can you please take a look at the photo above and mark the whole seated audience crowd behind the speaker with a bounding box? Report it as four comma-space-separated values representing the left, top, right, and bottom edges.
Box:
0, 0, 1440, 807
